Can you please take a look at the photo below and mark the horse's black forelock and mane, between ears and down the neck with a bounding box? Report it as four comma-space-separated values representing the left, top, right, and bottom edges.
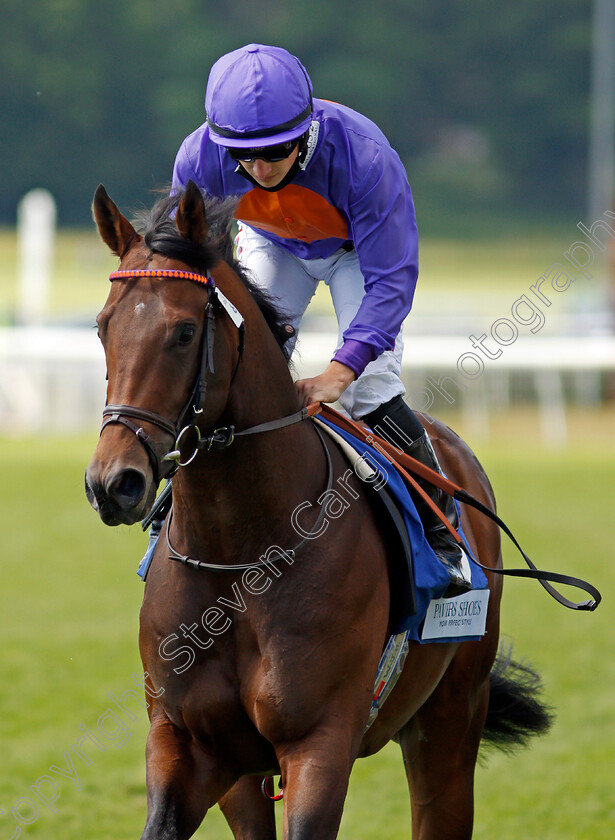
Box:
135, 190, 292, 360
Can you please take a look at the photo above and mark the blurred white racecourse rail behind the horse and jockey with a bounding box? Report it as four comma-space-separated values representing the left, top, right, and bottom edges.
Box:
0, 326, 615, 445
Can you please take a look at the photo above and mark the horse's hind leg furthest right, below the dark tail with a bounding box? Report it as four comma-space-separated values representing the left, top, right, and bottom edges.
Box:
396, 674, 489, 840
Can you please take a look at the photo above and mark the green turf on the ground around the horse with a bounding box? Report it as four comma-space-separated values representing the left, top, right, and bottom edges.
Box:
0, 415, 615, 840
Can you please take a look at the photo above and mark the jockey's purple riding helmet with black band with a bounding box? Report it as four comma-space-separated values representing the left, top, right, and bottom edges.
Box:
205, 44, 312, 149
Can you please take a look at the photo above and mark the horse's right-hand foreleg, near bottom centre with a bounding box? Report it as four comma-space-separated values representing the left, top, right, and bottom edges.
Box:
278, 722, 356, 840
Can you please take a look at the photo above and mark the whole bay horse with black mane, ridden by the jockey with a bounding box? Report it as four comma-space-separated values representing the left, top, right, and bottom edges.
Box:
86, 183, 549, 840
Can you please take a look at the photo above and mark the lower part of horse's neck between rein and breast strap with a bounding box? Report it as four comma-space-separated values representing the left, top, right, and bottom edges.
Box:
168, 410, 327, 563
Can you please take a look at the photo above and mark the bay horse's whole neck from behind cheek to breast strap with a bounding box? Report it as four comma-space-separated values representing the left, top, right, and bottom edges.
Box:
168, 278, 326, 561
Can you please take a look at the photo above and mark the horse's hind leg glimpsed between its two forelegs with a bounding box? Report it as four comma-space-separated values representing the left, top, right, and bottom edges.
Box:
219, 776, 276, 840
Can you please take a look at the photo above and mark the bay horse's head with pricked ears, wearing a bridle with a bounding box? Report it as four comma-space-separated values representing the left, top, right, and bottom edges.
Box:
85, 183, 256, 525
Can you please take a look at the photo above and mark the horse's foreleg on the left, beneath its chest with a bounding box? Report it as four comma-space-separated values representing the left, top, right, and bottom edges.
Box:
141, 709, 234, 840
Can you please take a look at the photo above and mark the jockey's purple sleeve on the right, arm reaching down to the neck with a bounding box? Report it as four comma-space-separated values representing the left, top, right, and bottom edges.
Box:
333, 144, 418, 375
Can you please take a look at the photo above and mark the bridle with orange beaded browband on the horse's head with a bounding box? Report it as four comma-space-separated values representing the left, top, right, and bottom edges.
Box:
100, 269, 317, 484
